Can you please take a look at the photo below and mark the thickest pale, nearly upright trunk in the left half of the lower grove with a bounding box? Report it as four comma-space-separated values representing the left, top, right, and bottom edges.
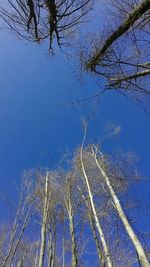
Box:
38, 172, 49, 267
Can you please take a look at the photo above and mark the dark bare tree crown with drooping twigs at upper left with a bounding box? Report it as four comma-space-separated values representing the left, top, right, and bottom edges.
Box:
0, 0, 93, 52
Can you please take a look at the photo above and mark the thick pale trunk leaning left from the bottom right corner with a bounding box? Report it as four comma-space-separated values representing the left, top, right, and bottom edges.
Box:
94, 152, 150, 267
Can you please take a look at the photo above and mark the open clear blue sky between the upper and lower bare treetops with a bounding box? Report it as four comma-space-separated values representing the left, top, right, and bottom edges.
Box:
0, 31, 150, 233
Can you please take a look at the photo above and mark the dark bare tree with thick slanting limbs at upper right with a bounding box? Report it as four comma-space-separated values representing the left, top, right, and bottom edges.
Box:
81, 0, 150, 111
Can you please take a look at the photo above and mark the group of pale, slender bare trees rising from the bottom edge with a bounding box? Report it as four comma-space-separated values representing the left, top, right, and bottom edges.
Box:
0, 146, 150, 267
